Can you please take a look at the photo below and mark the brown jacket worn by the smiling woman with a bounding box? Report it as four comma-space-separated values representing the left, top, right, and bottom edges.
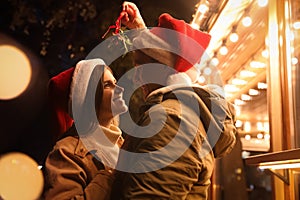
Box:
43, 138, 114, 200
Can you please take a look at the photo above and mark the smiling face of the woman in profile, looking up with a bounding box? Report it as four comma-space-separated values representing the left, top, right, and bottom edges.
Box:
99, 69, 127, 121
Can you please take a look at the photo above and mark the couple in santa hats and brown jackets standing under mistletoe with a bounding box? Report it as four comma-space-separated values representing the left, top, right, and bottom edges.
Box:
44, 2, 236, 199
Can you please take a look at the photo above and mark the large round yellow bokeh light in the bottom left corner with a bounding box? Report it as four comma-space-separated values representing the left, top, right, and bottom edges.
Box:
0, 152, 44, 200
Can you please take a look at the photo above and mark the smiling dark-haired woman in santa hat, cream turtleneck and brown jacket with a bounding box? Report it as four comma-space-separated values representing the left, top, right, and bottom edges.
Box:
43, 59, 127, 200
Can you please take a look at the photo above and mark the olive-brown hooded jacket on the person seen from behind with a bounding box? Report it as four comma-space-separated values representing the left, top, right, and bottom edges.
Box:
113, 85, 236, 200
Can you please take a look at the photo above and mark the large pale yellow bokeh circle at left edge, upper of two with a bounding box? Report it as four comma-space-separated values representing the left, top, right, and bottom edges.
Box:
0, 45, 32, 100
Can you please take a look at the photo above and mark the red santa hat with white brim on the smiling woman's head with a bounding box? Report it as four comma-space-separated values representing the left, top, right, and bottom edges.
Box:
48, 59, 105, 138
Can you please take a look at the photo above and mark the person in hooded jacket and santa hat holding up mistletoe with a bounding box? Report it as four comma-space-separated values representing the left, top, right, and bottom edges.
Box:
113, 2, 236, 200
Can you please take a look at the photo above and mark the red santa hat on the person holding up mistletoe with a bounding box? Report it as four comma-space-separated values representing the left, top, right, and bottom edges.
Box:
133, 13, 211, 72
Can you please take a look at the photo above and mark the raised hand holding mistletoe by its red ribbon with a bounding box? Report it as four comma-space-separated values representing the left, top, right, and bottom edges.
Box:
120, 1, 146, 29
